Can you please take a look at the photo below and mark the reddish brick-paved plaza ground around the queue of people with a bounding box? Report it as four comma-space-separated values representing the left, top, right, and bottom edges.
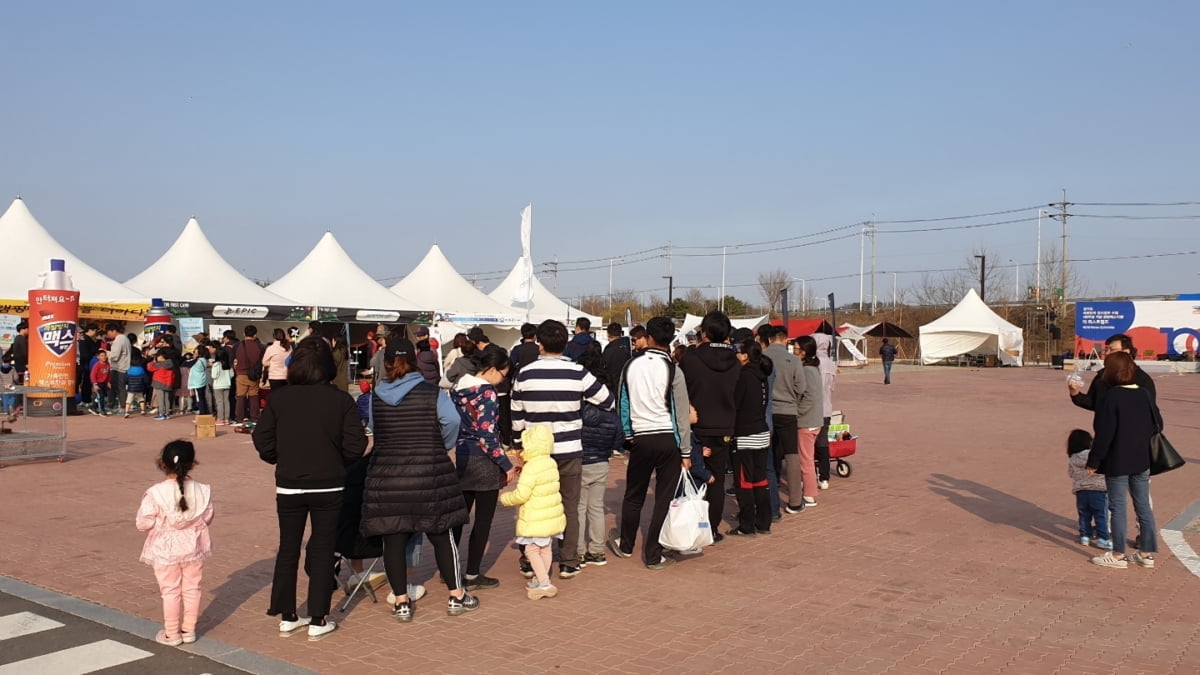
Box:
0, 368, 1200, 673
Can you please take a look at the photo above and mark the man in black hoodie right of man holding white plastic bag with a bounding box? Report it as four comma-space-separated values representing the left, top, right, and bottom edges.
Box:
679, 311, 742, 543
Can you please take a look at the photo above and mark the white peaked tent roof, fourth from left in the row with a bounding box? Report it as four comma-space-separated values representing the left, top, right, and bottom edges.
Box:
391, 244, 524, 325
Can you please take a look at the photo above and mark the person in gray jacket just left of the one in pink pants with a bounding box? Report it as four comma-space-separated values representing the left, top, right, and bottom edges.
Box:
766, 327, 812, 513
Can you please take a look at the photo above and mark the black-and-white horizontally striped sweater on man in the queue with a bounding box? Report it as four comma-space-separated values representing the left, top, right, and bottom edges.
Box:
511, 356, 613, 459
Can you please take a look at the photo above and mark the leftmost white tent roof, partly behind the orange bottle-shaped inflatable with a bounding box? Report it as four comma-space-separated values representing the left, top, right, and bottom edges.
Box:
0, 197, 150, 305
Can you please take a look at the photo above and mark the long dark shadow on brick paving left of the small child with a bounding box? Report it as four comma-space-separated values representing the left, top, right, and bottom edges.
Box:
929, 473, 1080, 551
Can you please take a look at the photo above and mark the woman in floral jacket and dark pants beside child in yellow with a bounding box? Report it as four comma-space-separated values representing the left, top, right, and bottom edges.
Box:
450, 350, 517, 591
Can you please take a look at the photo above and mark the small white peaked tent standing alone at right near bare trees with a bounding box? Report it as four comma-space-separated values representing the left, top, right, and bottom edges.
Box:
920, 288, 1025, 365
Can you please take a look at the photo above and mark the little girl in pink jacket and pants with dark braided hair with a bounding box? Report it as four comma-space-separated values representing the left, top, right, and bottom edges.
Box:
137, 441, 212, 646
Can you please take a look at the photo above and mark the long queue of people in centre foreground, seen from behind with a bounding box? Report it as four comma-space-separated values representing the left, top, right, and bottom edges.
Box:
152, 312, 832, 643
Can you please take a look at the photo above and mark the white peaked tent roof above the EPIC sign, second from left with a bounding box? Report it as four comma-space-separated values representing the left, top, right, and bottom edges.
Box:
125, 217, 296, 306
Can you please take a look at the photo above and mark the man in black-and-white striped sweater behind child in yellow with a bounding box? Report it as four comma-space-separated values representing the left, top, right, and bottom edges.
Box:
511, 319, 613, 579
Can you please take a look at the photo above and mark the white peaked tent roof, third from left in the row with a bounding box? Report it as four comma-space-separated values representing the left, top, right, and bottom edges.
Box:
266, 232, 427, 311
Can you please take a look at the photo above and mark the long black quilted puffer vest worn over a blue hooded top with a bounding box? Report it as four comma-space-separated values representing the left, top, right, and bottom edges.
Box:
362, 382, 468, 537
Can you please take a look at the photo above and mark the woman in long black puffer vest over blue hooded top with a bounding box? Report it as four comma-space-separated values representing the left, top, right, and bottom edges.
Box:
362, 340, 479, 621
